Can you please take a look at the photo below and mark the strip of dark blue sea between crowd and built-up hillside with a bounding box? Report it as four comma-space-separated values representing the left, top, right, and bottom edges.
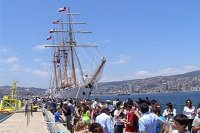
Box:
90, 91, 200, 113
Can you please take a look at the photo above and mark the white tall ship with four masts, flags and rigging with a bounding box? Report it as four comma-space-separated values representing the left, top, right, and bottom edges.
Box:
46, 7, 106, 99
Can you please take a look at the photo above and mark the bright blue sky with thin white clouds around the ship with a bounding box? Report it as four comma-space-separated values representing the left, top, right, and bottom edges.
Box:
0, 0, 200, 88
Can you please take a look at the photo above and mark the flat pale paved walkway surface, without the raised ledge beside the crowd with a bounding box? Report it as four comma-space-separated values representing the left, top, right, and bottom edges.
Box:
0, 112, 49, 133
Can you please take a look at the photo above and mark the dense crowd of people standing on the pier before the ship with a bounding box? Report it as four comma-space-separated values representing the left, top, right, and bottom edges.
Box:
43, 98, 200, 133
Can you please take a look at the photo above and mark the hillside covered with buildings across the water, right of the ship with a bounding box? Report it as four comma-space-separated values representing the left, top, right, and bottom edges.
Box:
96, 70, 200, 94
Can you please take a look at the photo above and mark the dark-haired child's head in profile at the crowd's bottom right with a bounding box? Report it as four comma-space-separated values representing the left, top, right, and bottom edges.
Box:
172, 114, 190, 133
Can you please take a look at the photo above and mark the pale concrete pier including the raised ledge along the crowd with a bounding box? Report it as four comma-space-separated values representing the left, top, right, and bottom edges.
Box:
0, 111, 69, 133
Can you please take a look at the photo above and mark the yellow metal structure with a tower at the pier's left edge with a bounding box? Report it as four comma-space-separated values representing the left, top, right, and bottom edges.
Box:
0, 81, 22, 113
